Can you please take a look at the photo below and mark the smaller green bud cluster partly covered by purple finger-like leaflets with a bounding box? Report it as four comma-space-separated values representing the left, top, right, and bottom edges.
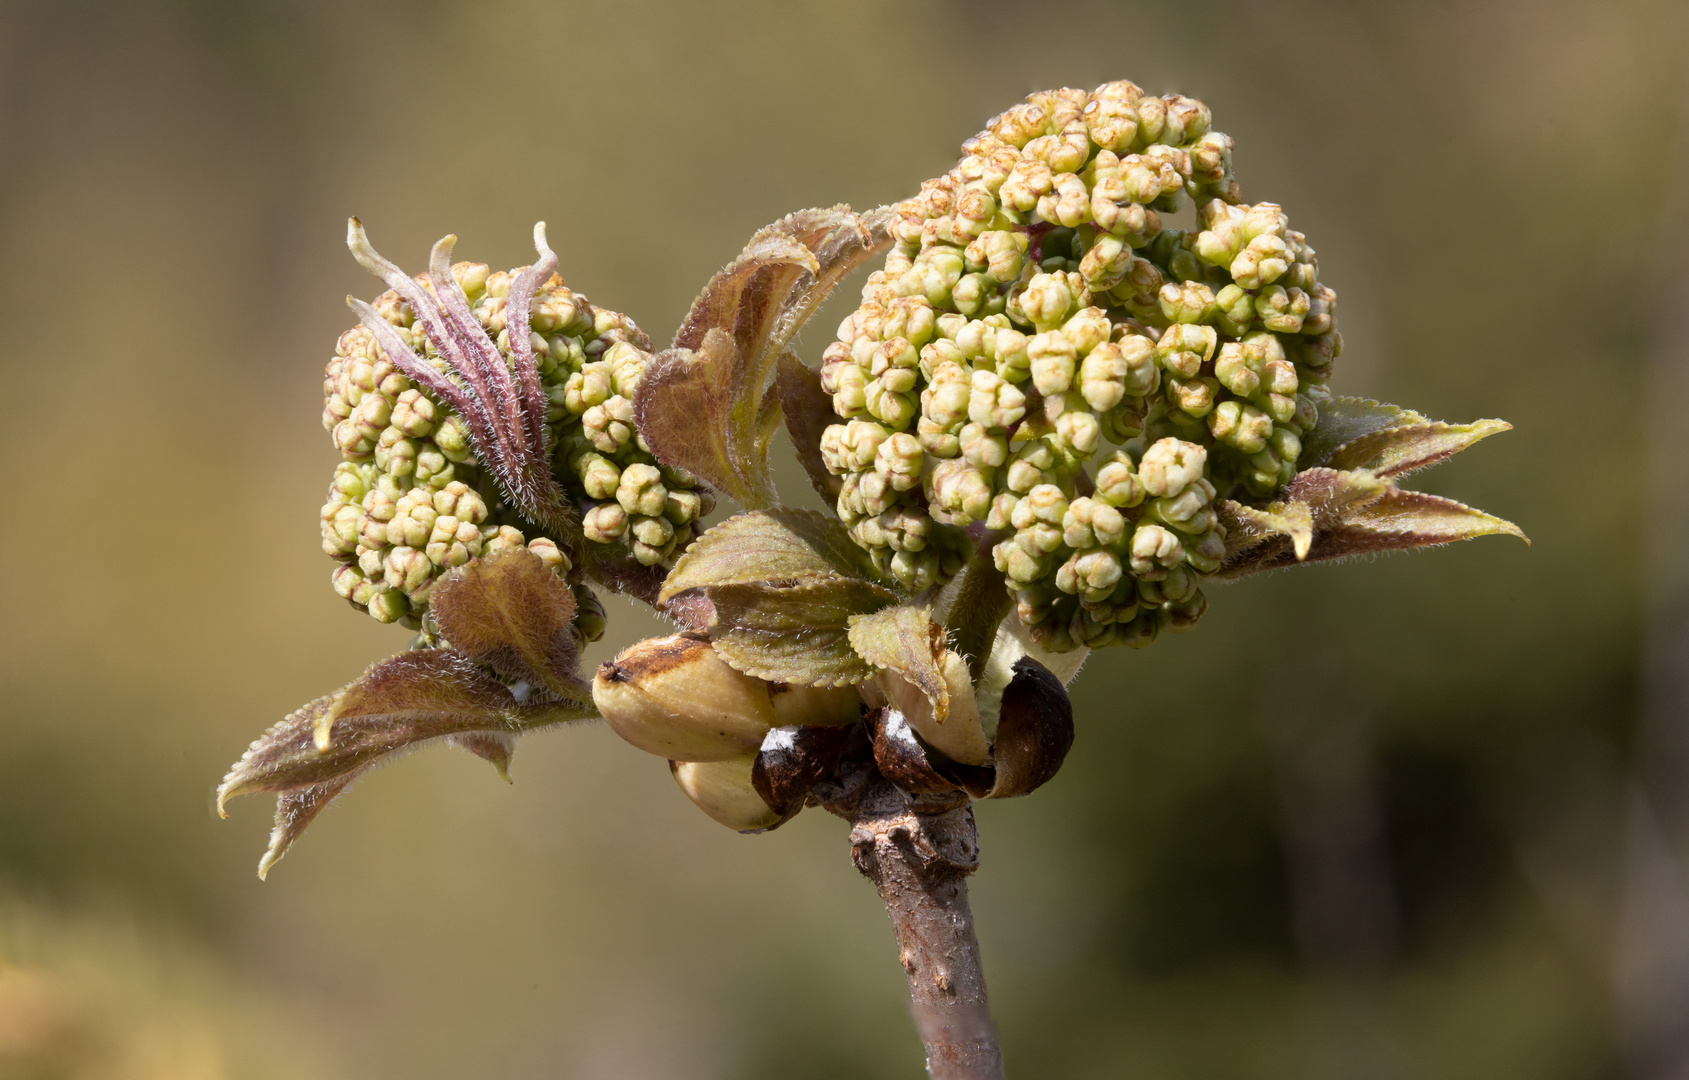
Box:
323, 262, 711, 625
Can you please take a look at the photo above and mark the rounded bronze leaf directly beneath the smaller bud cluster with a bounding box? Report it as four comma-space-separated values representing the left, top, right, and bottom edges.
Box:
429, 548, 591, 701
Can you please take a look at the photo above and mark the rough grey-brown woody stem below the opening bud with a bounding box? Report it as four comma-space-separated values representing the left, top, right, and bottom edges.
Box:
826, 766, 1003, 1080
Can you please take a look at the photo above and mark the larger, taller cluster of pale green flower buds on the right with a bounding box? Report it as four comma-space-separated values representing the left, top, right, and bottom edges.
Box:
821, 81, 1343, 649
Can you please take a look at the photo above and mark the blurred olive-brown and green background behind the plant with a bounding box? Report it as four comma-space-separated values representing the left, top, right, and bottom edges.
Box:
0, 0, 1689, 1080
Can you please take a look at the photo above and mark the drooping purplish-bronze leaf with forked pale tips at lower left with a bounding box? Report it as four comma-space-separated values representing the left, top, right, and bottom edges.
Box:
216, 649, 593, 877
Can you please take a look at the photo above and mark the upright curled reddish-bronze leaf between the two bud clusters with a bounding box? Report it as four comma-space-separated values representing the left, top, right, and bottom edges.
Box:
633, 206, 890, 509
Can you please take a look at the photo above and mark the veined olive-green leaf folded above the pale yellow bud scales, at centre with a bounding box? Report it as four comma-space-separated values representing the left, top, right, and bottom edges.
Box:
659, 507, 875, 603
